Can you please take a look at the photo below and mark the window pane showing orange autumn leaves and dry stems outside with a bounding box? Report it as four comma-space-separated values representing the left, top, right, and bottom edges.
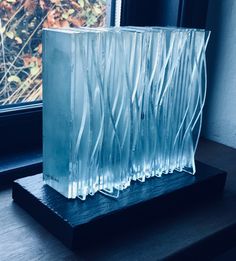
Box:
0, 0, 106, 105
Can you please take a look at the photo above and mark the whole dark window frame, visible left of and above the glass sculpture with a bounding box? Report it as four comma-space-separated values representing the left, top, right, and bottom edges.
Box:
0, 0, 209, 187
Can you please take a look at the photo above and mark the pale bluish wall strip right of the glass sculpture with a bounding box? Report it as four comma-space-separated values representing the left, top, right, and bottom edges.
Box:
202, 0, 236, 148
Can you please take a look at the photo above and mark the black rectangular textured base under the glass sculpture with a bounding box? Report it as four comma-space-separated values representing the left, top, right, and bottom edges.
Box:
13, 162, 226, 248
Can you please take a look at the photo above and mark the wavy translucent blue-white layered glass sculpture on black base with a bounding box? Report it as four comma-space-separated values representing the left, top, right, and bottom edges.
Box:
43, 27, 209, 200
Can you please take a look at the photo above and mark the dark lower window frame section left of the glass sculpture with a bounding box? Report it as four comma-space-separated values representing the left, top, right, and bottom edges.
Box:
0, 102, 42, 187
